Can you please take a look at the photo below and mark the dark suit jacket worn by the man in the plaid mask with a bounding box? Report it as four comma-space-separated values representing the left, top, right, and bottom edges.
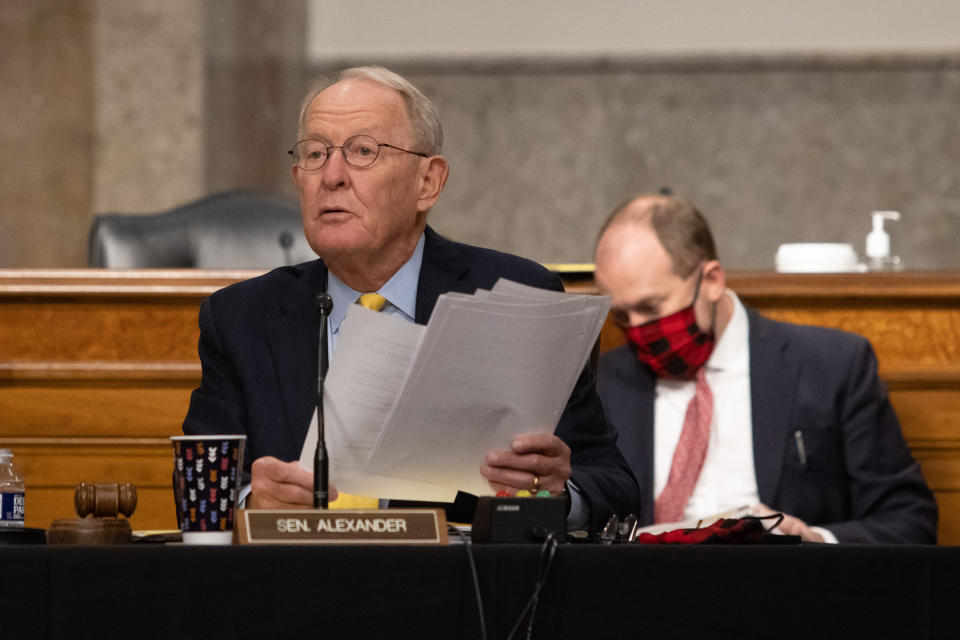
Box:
598, 310, 937, 543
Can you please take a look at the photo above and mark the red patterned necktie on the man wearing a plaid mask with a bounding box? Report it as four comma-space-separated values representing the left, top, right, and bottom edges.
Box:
653, 367, 713, 522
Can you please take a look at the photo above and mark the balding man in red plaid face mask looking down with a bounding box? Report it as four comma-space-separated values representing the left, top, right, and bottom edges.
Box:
596, 195, 937, 543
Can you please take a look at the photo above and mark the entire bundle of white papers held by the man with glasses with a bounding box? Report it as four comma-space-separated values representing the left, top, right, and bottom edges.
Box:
300, 280, 610, 502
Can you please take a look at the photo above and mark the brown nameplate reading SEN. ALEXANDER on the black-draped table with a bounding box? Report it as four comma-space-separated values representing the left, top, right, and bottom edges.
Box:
234, 509, 447, 544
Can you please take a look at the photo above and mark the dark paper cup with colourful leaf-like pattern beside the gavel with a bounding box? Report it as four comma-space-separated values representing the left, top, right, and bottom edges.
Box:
171, 436, 246, 532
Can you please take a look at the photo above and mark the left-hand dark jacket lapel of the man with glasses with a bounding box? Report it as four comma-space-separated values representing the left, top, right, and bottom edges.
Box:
267, 260, 327, 456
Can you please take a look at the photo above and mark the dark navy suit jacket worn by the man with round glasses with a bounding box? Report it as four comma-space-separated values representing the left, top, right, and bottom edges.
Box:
183, 227, 640, 531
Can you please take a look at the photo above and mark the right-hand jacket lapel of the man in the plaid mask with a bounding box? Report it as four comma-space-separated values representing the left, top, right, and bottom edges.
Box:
748, 309, 800, 504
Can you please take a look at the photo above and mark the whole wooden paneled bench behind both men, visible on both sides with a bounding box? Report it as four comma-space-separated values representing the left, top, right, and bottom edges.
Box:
0, 269, 960, 544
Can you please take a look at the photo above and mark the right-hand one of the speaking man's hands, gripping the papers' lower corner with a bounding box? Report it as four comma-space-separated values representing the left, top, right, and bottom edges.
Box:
480, 433, 570, 494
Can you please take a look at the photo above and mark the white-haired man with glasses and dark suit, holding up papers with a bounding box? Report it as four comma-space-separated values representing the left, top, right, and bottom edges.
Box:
183, 67, 640, 530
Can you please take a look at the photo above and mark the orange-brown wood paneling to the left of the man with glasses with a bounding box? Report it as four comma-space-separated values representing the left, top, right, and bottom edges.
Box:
0, 269, 256, 529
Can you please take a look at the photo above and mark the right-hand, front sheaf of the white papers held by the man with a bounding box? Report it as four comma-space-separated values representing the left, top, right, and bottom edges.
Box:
368, 293, 599, 495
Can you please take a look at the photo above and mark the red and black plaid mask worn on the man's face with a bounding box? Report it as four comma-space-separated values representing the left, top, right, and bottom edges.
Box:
624, 270, 717, 380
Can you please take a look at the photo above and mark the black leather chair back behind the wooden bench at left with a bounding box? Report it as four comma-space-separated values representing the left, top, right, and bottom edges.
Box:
89, 190, 317, 269
